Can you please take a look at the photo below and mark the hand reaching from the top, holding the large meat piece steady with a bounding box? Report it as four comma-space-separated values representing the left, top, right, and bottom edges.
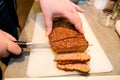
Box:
40, 0, 84, 35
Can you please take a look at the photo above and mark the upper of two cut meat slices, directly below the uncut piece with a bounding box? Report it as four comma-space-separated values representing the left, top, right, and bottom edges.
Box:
54, 53, 90, 64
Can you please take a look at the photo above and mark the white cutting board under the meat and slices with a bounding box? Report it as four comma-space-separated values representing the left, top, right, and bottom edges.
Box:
27, 13, 113, 77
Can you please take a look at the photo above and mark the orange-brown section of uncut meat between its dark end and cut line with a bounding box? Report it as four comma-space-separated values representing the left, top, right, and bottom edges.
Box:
49, 26, 81, 42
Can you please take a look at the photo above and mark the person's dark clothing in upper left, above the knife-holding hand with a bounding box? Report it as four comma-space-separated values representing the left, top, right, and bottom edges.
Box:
0, 0, 19, 39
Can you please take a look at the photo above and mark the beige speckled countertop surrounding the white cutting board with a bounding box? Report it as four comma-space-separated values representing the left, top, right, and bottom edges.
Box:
4, 1, 120, 79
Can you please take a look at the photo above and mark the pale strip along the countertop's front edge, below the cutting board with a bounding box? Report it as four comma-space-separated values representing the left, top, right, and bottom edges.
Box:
5, 75, 120, 80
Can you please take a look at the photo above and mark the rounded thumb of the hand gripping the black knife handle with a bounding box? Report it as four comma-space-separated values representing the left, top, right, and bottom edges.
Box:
7, 41, 22, 55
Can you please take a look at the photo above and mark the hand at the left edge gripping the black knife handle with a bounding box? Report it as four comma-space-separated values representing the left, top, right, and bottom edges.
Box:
0, 30, 21, 58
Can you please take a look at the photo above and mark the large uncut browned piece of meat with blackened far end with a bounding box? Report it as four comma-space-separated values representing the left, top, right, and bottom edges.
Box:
49, 17, 88, 53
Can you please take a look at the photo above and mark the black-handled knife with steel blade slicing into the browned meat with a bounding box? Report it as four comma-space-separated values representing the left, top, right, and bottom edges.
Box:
14, 41, 50, 48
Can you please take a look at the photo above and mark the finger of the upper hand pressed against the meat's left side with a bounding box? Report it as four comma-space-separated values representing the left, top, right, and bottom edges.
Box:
45, 16, 52, 35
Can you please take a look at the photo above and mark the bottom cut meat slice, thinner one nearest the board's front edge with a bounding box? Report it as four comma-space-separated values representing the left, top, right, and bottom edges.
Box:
57, 63, 90, 73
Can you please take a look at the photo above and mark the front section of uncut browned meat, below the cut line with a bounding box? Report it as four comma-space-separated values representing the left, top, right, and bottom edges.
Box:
51, 38, 88, 53
